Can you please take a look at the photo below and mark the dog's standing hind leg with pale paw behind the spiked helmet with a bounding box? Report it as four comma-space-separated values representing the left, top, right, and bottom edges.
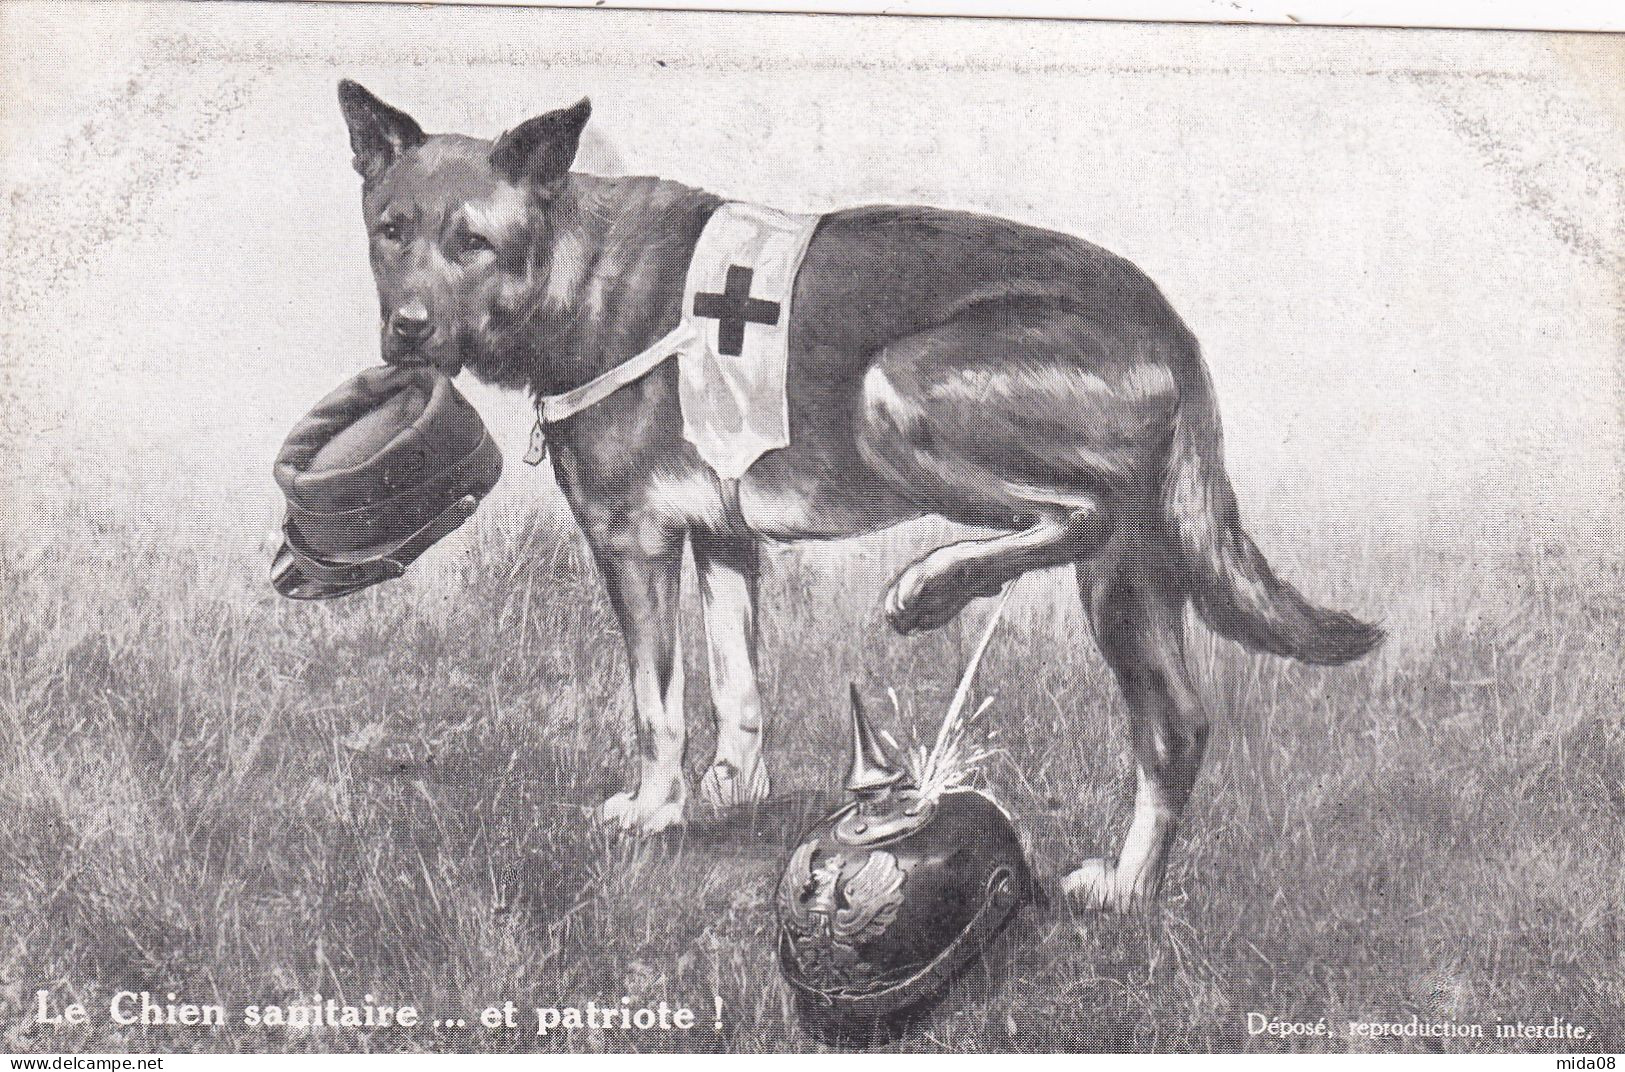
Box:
1063, 565, 1209, 910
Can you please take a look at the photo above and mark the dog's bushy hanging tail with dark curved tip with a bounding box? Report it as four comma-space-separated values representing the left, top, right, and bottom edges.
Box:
1162, 361, 1383, 664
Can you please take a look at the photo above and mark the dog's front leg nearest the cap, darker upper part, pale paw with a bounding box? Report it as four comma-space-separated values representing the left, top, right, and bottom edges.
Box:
593, 539, 689, 833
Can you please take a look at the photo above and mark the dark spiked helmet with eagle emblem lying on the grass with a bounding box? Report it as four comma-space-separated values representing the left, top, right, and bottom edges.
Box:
777, 685, 1042, 1036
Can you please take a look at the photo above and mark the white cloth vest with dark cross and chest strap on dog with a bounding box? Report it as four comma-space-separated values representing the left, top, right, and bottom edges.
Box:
525, 201, 819, 481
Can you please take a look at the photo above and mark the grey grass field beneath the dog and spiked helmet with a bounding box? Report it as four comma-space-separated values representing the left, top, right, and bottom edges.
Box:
0, 507, 1625, 1051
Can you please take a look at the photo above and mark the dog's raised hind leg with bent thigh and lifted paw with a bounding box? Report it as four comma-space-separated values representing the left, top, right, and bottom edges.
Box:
856, 304, 1177, 633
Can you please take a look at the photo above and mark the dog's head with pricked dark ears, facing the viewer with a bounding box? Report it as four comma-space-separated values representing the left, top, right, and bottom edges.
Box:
338, 80, 592, 385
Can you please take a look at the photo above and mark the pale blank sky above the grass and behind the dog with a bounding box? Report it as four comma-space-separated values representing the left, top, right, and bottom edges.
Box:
0, 2, 1625, 565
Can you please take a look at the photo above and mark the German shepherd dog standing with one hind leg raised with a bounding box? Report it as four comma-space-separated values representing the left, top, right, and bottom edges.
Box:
338, 81, 1381, 908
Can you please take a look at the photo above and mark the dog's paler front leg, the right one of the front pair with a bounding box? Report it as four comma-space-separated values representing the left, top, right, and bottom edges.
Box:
689, 531, 770, 807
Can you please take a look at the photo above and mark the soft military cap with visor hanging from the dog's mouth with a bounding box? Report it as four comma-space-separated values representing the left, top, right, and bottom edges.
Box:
271, 365, 502, 599
